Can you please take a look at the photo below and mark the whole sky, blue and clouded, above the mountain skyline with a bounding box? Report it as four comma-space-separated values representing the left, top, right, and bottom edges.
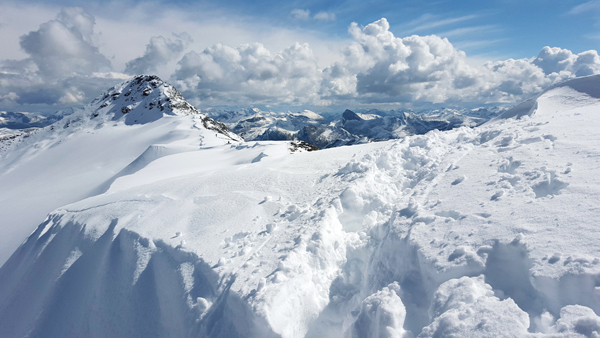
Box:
0, 0, 600, 112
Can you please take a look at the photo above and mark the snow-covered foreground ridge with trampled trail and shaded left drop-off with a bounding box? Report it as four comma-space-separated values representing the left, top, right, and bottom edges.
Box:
0, 77, 600, 337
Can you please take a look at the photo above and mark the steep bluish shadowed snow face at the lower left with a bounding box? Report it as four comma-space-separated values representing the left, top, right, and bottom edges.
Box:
0, 217, 273, 337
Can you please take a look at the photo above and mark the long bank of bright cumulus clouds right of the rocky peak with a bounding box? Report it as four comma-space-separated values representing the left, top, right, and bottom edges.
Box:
166, 19, 600, 106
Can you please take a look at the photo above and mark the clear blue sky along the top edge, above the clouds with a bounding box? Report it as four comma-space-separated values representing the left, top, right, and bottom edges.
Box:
32, 0, 600, 58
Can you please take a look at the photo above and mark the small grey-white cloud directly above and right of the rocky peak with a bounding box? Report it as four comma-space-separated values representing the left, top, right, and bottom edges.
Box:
125, 33, 193, 74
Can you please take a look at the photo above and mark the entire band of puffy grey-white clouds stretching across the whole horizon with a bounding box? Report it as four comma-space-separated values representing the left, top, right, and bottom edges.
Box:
0, 8, 600, 109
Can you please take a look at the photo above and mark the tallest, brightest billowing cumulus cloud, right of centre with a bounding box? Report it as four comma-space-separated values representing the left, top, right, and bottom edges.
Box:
323, 19, 479, 102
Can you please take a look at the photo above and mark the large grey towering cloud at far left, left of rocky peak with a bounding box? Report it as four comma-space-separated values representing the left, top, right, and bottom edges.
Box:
0, 8, 124, 107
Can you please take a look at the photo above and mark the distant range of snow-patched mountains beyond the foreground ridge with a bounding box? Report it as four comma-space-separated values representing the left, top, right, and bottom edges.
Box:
207, 107, 503, 149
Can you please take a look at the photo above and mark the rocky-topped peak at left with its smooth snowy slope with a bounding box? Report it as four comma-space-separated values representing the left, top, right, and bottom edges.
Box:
0, 76, 240, 263
